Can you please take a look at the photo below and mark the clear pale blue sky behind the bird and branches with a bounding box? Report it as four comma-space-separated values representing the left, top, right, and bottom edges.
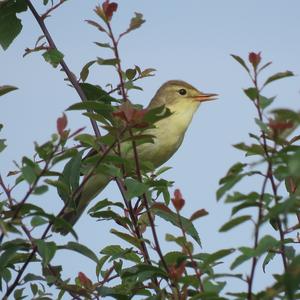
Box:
0, 0, 300, 298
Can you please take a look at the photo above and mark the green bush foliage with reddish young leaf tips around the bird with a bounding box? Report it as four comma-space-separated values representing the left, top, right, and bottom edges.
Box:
0, 0, 300, 300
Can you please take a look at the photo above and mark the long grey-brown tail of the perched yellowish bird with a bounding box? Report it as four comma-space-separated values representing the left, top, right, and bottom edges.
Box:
53, 174, 110, 235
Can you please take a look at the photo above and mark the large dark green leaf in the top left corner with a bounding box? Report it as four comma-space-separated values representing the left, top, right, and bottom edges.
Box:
0, 0, 27, 50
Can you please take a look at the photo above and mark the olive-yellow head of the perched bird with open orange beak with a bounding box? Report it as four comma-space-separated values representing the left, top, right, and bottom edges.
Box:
150, 80, 217, 112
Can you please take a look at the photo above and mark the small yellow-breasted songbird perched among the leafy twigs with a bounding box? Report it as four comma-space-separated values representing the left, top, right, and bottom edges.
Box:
58, 80, 218, 234
